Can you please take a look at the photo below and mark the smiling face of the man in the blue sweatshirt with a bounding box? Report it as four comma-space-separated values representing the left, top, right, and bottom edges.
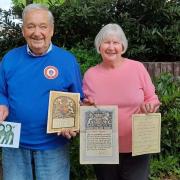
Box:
22, 9, 54, 55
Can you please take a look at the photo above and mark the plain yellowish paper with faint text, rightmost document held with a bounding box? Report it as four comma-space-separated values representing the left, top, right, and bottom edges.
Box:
132, 113, 161, 156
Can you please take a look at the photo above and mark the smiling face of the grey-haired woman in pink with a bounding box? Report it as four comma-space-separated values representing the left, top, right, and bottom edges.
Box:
99, 35, 123, 62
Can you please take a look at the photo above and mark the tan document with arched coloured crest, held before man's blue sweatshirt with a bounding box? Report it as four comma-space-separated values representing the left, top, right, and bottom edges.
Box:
47, 91, 80, 133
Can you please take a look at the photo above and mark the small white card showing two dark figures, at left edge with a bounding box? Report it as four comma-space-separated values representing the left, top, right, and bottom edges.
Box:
0, 121, 21, 148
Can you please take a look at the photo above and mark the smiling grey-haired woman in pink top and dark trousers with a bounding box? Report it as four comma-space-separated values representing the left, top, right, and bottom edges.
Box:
83, 24, 160, 180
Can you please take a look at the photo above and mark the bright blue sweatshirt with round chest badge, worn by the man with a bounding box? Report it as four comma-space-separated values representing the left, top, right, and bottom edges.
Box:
0, 45, 83, 150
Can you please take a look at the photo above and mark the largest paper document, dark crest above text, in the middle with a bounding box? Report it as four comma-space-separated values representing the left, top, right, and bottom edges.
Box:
80, 106, 119, 164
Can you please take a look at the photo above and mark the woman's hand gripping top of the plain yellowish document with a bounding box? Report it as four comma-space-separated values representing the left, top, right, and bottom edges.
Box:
140, 103, 160, 114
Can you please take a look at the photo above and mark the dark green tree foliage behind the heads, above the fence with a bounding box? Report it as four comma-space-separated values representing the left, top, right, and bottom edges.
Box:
0, 0, 180, 61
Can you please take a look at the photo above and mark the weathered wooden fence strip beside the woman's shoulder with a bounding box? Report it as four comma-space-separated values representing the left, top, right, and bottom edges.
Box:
143, 62, 180, 78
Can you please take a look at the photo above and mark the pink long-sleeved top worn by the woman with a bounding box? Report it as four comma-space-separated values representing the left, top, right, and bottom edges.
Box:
83, 59, 159, 153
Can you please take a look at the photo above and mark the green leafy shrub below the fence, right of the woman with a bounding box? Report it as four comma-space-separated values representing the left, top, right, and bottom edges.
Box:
150, 73, 180, 180
